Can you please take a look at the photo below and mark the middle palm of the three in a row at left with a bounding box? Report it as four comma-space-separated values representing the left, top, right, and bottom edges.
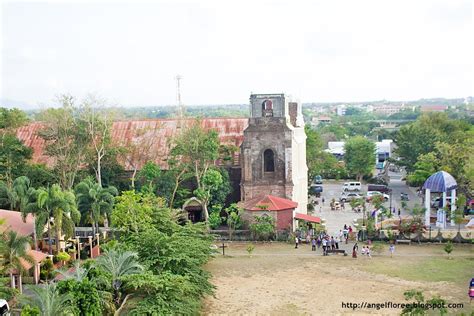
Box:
37, 184, 81, 254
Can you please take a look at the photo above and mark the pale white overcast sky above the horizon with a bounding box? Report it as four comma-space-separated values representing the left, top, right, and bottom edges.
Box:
0, 0, 474, 106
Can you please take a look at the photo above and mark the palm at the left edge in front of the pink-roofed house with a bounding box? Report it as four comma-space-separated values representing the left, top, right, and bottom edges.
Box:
0, 230, 35, 293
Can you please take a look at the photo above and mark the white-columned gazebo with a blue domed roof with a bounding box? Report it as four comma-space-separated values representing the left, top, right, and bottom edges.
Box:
423, 171, 458, 228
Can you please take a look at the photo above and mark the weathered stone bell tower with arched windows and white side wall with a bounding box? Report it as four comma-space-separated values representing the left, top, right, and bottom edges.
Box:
240, 94, 308, 214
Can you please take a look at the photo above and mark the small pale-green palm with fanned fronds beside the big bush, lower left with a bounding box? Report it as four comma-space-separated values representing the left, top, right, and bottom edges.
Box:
95, 250, 144, 305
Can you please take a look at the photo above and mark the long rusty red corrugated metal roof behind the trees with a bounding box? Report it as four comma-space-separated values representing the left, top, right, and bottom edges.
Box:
17, 118, 248, 170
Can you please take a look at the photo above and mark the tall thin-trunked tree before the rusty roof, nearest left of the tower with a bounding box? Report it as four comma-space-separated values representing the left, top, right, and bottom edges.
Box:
172, 121, 222, 221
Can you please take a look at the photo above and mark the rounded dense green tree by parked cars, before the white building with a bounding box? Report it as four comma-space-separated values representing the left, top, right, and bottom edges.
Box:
344, 136, 375, 181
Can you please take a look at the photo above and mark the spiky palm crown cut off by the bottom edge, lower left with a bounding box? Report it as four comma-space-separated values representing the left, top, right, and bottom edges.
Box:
20, 283, 72, 316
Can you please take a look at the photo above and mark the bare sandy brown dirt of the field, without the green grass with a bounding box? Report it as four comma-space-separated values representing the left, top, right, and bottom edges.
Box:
203, 244, 469, 315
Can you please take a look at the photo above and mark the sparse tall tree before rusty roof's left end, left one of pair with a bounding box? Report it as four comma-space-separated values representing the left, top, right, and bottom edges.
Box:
38, 95, 90, 190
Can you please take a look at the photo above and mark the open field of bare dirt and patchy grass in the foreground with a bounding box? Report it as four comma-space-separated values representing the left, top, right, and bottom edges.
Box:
203, 243, 474, 315
